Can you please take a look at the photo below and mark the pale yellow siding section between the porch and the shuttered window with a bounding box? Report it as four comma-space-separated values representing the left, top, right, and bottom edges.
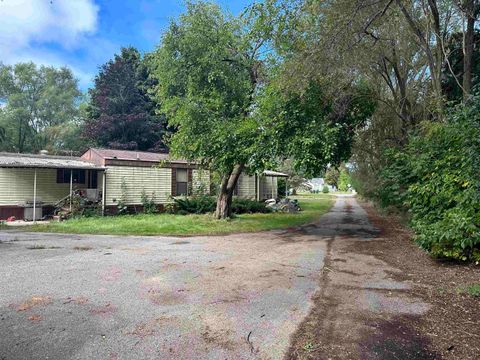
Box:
105, 166, 172, 206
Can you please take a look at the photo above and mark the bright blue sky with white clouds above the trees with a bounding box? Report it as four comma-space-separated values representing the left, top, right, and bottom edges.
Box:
0, 0, 252, 90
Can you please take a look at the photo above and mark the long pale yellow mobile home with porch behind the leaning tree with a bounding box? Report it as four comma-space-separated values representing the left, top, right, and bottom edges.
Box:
0, 148, 287, 219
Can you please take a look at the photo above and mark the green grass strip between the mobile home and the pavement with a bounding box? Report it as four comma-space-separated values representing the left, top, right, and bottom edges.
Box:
26, 194, 334, 236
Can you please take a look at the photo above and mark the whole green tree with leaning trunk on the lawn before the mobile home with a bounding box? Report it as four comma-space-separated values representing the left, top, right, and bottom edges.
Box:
150, 2, 376, 218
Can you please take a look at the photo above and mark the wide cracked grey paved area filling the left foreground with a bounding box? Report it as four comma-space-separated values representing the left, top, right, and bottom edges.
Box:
0, 210, 330, 359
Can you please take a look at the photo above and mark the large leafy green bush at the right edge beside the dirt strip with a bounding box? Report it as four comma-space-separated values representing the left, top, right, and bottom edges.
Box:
377, 97, 480, 261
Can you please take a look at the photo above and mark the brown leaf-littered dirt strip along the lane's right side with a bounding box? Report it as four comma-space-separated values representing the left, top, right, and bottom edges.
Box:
355, 203, 480, 359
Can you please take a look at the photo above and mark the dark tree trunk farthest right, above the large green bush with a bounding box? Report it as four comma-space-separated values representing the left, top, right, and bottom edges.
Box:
463, 0, 476, 99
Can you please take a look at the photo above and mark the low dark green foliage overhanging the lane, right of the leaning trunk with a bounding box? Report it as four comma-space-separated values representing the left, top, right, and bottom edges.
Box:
260, 82, 376, 177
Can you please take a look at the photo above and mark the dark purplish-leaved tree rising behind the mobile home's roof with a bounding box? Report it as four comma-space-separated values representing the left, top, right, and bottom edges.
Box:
84, 47, 166, 150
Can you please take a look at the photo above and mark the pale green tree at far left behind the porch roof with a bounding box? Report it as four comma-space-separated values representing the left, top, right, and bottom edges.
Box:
0, 63, 81, 152
